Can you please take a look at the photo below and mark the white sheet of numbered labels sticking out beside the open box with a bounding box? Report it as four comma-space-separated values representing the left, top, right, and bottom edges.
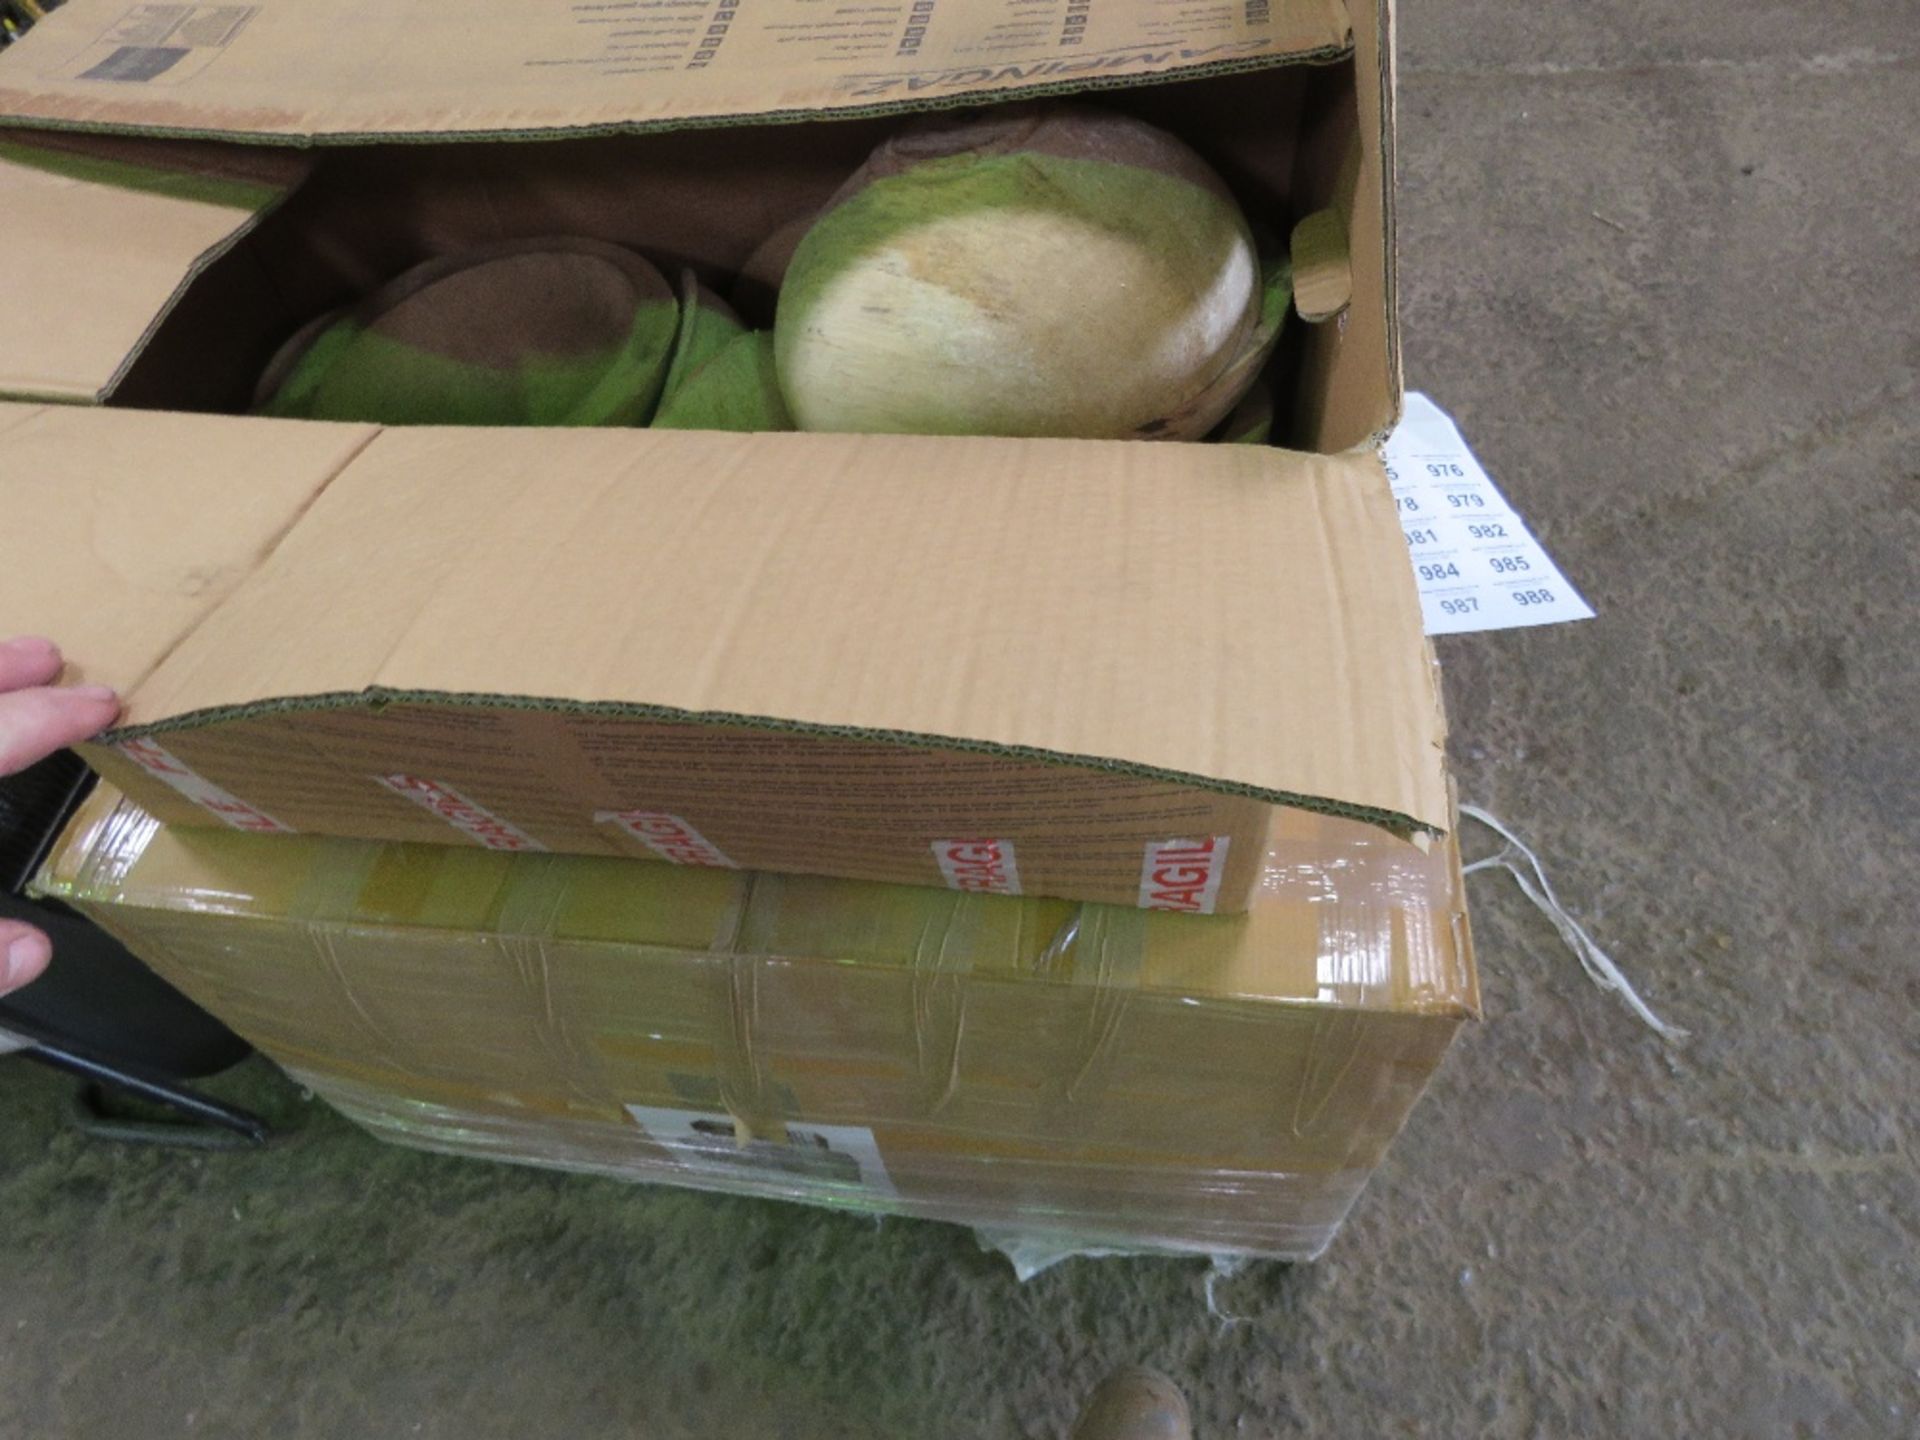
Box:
1384, 392, 1594, 636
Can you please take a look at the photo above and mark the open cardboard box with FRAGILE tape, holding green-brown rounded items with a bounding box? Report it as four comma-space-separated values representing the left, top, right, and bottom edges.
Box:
0, 0, 1450, 910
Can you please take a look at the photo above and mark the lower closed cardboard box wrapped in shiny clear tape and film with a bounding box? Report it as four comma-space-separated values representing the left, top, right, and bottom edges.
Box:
40, 787, 1478, 1258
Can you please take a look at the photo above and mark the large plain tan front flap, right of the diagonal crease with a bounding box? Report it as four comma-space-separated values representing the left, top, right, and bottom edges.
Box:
108, 419, 1448, 829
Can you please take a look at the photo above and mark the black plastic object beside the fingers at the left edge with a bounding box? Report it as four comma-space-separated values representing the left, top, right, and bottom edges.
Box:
0, 753, 252, 1089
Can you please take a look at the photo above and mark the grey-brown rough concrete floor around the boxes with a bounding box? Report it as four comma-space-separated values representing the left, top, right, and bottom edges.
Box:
0, 0, 1920, 1440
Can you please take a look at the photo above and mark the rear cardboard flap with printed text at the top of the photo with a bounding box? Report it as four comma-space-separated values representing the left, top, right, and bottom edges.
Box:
0, 0, 1352, 140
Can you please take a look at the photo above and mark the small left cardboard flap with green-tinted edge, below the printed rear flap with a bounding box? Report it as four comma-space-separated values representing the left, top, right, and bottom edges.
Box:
0, 131, 307, 401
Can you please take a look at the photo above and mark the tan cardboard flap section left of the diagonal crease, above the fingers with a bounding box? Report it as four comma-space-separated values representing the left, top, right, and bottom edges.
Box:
0, 403, 374, 691
